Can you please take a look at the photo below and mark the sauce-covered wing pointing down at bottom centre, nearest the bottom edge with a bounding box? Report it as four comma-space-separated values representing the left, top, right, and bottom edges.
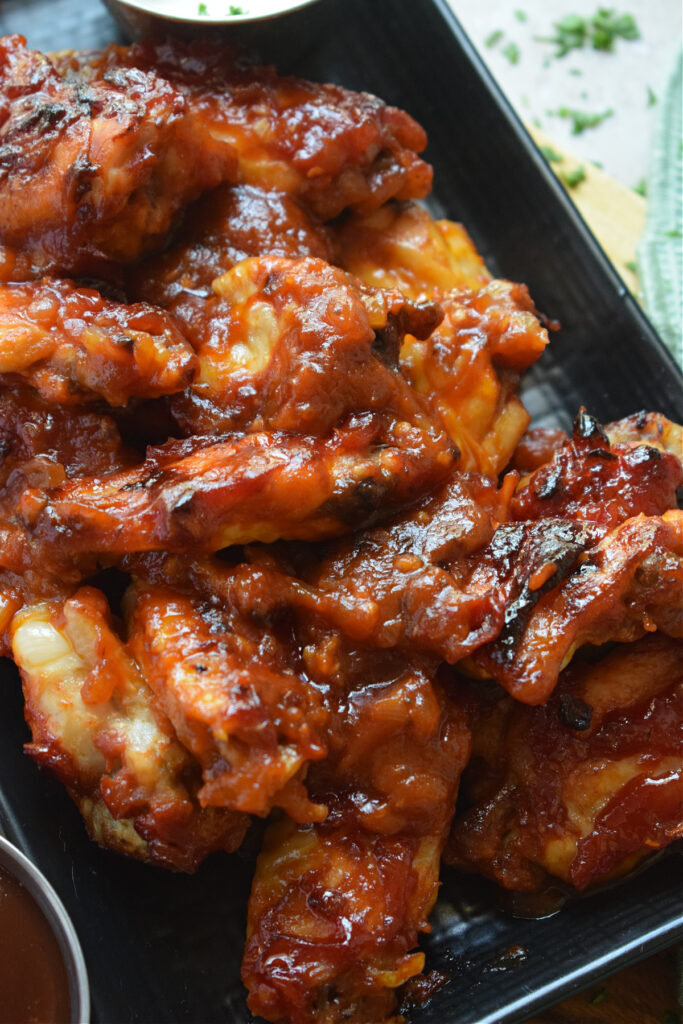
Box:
243, 663, 470, 1024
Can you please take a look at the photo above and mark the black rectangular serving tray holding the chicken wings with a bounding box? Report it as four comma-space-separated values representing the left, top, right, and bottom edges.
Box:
0, 0, 683, 1024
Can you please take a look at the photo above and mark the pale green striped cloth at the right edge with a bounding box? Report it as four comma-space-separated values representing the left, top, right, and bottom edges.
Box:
638, 50, 683, 367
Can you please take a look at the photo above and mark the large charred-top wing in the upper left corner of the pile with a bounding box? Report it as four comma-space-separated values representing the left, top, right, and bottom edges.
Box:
0, 36, 236, 281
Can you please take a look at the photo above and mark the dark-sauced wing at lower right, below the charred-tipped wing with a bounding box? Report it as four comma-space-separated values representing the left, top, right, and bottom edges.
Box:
446, 634, 683, 890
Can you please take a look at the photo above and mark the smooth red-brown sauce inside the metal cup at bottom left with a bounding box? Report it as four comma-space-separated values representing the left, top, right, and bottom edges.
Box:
0, 867, 71, 1024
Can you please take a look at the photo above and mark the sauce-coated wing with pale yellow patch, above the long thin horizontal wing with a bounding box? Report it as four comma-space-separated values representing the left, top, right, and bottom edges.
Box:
153, 256, 441, 435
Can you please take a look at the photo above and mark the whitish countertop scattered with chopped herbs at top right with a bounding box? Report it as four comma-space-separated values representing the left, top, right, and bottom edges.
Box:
449, 0, 683, 187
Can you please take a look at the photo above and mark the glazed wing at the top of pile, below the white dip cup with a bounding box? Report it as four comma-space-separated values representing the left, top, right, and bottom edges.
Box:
85, 42, 432, 220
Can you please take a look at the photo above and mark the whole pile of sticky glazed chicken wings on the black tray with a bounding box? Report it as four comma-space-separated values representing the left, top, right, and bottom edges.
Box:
0, 37, 683, 1024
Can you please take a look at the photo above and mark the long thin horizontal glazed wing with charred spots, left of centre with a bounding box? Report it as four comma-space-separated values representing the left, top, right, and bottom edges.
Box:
18, 415, 454, 563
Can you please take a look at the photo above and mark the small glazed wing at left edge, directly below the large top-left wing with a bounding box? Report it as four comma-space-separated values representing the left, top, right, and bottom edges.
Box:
0, 279, 197, 406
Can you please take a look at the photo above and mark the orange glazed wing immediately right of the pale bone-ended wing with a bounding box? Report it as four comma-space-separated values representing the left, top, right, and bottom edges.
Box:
127, 582, 327, 821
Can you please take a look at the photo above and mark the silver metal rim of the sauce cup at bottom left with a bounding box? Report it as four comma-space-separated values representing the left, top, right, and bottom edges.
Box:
0, 835, 90, 1024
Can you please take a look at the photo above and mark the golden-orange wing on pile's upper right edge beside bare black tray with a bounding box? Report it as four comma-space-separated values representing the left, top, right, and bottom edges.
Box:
335, 204, 548, 476
